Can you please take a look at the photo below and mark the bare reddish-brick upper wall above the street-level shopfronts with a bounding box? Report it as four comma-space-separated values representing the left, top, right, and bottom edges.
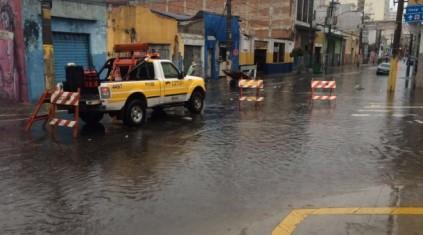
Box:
142, 0, 296, 39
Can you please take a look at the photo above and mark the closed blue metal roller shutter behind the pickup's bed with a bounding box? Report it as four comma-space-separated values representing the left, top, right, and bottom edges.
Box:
53, 32, 90, 81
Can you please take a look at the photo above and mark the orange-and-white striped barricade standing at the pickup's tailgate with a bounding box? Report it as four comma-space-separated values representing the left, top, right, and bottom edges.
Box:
49, 89, 80, 138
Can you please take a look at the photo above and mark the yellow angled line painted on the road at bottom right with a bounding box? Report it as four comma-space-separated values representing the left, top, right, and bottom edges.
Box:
272, 207, 423, 235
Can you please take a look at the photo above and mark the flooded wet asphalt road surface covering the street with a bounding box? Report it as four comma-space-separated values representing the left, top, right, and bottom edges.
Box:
0, 63, 423, 235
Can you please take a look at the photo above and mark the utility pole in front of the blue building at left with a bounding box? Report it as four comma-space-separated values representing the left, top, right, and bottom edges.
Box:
41, 0, 56, 89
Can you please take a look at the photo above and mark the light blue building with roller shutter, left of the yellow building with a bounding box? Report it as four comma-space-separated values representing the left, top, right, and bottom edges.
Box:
22, 0, 107, 101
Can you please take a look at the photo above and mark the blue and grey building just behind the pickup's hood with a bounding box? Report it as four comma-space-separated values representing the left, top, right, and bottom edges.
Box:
152, 10, 240, 79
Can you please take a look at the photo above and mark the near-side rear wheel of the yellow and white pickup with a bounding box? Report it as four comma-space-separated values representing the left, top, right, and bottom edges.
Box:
123, 99, 147, 126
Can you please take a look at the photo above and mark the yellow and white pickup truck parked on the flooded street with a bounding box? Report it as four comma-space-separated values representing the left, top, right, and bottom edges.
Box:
64, 58, 206, 126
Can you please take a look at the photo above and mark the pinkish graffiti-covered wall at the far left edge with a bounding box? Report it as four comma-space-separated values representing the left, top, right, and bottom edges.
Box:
0, 0, 28, 101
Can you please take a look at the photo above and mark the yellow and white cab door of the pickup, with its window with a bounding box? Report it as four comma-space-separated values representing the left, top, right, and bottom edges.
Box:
161, 61, 188, 103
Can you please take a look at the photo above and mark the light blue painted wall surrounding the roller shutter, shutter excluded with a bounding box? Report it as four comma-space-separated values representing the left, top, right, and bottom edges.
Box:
23, 0, 107, 101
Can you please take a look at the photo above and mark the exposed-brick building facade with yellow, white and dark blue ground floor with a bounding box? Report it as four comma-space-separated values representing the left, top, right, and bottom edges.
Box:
136, 0, 294, 73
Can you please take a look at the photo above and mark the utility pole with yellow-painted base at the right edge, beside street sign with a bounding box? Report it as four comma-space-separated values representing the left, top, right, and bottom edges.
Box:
388, 0, 404, 92
